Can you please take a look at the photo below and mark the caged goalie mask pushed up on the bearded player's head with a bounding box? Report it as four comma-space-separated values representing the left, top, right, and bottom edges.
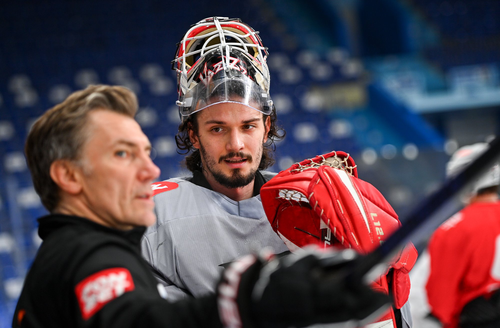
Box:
172, 17, 273, 121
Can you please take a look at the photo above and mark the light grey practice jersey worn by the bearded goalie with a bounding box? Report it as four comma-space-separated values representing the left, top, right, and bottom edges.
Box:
142, 172, 288, 300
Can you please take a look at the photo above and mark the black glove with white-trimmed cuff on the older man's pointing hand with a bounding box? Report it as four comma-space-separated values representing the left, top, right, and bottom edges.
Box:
217, 248, 391, 328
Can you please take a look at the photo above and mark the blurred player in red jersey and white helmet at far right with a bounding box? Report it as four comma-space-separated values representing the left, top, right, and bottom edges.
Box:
426, 143, 500, 328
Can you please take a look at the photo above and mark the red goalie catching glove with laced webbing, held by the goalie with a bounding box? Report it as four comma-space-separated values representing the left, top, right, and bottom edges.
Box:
260, 151, 417, 309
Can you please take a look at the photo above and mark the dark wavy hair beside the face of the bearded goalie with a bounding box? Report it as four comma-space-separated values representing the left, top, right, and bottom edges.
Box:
175, 106, 286, 172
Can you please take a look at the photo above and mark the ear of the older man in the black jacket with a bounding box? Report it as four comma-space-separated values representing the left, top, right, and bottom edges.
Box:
50, 159, 82, 195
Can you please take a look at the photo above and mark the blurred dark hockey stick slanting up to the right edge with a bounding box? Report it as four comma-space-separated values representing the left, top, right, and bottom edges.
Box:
349, 138, 500, 281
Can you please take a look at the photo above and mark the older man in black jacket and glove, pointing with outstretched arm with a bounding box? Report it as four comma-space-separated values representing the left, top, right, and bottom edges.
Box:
13, 86, 387, 328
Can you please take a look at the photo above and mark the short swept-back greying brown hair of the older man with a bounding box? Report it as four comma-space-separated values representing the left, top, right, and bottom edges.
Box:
24, 85, 138, 212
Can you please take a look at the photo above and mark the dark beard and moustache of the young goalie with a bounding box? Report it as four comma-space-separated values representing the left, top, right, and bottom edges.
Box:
200, 142, 263, 189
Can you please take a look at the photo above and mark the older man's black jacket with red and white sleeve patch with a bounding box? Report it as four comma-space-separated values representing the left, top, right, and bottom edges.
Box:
12, 215, 221, 328
